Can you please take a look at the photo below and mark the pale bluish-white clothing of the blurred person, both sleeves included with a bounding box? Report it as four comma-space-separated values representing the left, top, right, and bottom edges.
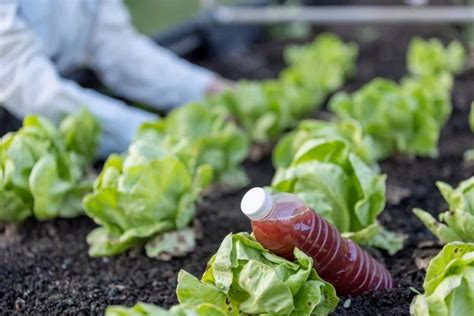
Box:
0, 0, 215, 155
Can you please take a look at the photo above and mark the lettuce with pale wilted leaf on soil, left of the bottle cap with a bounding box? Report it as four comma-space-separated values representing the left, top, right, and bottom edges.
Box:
83, 155, 212, 257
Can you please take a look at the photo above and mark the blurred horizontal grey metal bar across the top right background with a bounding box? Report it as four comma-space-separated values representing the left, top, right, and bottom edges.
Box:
212, 6, 474, 24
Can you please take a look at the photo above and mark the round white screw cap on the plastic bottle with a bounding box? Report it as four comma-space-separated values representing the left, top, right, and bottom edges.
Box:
240, 187, 273, 220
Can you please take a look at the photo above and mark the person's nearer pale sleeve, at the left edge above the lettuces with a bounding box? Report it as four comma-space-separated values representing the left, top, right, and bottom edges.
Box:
0, 0, 156, 155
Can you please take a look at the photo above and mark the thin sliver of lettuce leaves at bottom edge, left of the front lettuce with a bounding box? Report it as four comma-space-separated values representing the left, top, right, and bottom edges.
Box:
105, 303, 226, 316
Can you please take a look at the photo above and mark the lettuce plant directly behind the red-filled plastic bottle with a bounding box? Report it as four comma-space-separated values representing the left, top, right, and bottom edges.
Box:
272, 138, 403, 254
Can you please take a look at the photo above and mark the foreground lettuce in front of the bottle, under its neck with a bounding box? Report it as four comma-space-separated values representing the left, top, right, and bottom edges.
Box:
177, 233, 339, 315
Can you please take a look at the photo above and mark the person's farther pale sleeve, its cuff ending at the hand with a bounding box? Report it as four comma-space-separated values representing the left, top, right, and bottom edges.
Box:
90, 0, 215, 109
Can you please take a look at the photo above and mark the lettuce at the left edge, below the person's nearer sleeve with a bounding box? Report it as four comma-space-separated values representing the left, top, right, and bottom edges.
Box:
0, 109, 100, 223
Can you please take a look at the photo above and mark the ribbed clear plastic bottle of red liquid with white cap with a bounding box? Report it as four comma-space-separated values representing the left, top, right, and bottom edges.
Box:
241, 188, 393, 296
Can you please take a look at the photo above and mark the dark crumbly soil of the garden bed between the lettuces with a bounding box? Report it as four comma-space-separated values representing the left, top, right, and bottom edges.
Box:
0, 26, 474, 315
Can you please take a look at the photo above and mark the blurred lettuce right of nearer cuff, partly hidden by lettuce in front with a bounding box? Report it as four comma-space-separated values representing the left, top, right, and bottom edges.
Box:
125, 103, 249, 187
